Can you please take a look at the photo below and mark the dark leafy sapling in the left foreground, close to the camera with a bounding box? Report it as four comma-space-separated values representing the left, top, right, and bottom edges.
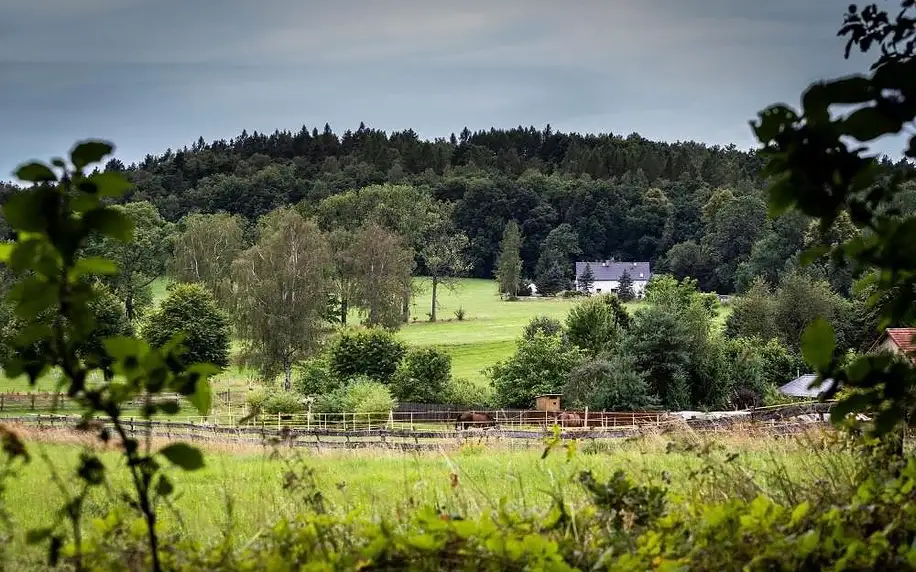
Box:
0, 141, 218, 571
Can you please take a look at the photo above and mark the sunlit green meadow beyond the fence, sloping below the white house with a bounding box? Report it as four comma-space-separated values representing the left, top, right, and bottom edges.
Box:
0, 278, 728, 402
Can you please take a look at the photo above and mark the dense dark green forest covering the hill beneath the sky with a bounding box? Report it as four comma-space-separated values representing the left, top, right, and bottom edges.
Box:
6, 125, 916, 293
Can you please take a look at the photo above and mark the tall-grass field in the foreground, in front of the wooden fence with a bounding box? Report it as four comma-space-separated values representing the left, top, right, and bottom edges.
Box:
4, 428, 835, 561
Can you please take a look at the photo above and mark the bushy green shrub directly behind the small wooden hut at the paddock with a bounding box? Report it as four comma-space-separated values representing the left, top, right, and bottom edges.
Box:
487, 332, 582, 408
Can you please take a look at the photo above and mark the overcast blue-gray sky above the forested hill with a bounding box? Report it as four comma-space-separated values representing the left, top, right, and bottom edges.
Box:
0, 0, 893, 179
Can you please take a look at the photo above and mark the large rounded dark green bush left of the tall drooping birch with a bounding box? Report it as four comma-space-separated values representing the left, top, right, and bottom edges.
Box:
143, 284, 230, 367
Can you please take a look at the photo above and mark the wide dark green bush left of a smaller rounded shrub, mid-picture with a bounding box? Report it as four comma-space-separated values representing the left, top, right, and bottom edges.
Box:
330, 328, 407, 383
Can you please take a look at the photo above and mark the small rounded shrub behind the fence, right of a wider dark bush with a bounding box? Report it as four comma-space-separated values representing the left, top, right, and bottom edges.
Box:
392, 347, 452, 403
